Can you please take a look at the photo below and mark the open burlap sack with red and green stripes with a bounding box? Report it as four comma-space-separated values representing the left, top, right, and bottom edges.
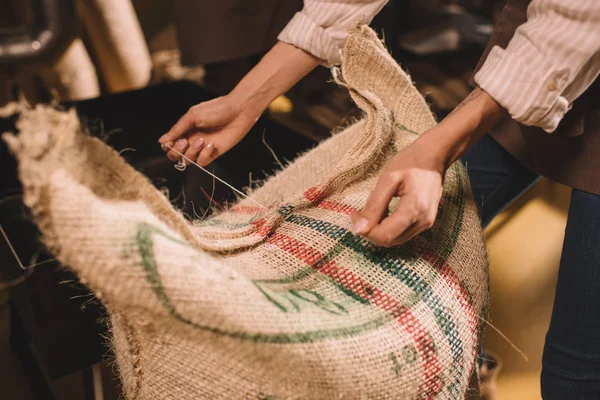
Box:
6, 26, 488, 400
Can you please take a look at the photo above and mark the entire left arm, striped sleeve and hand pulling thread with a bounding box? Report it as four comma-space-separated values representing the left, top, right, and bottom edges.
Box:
159, 0, 387, 165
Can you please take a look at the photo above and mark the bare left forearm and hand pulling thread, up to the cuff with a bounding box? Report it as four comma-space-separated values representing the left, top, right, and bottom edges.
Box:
158, 42, 320, 166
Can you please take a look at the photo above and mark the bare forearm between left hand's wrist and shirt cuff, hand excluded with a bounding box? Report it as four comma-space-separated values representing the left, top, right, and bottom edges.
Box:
231, 42, 320, 117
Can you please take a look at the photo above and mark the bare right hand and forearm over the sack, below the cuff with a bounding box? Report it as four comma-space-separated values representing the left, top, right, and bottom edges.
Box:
352, 88, 507, 247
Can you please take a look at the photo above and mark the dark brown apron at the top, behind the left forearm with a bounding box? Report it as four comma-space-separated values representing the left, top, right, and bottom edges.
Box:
175, 0, 303, 65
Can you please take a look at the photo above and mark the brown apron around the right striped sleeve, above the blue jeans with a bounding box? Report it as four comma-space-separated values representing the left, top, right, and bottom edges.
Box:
475, 0, 600, 194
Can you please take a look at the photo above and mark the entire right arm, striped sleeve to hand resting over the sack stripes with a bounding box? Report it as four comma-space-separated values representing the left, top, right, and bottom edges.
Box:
352, 0, 600, 246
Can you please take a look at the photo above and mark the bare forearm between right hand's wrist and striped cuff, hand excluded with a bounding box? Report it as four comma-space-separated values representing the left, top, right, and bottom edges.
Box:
418, 88, 508, 169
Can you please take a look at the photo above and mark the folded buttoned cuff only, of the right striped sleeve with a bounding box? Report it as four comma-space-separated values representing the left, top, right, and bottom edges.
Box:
475, 46, 571, 133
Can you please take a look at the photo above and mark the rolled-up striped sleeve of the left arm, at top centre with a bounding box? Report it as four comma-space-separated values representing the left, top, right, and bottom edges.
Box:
279, 0, 388, 66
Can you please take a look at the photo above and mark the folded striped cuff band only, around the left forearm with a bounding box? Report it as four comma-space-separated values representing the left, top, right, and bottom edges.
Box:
278, 12, 342, 67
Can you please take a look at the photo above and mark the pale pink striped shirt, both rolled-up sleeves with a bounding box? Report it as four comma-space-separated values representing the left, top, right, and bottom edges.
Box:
279, 0, 600, 132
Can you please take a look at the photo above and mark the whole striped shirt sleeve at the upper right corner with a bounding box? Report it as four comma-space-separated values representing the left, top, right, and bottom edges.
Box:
475, 0, 600, 132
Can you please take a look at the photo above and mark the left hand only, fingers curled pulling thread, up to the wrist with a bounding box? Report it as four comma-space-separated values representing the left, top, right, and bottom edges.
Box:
158, 94, 257, 166
